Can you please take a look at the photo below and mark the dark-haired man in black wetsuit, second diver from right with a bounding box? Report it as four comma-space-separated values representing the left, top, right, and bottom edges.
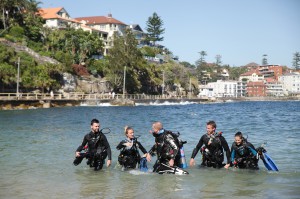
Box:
190, 121, 230, 169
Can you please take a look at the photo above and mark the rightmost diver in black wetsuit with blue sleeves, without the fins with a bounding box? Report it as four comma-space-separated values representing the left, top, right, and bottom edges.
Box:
231, 132, 258, 170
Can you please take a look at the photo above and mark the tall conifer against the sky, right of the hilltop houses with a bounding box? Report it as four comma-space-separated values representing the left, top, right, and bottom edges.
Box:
146, 12, 165, 44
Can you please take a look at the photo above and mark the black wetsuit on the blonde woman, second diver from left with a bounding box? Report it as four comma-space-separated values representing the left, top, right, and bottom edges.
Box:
117, 139, 147, 169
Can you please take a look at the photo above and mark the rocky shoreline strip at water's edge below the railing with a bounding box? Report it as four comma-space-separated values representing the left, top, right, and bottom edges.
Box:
0, 97, 300, 111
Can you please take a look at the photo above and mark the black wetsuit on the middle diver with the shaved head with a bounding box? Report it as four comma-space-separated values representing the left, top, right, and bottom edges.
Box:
149, 130, 180, 172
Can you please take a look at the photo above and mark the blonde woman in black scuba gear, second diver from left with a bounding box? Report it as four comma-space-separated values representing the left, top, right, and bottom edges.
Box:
117, 126, 147, 169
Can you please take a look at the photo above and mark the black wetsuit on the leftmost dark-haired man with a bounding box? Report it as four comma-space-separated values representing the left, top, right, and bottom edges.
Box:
76, 131, 111, 170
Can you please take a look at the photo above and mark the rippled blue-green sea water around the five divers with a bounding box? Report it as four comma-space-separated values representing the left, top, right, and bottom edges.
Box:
0, 101, 300, 199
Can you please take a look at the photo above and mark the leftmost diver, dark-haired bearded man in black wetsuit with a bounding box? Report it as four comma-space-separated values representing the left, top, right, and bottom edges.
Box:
73, 119, 111, 171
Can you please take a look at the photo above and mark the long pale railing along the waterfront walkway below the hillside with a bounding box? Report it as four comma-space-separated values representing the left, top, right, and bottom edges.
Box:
0, 92, 205, 101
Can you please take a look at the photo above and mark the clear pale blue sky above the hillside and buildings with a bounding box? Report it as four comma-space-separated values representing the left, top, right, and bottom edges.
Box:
39, 0, 300, 67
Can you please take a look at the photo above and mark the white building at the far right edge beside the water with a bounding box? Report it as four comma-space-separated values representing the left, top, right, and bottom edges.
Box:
278, 72, 300, 95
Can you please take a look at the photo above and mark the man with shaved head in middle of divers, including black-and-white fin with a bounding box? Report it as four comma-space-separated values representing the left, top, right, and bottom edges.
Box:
146, 122, 188, 175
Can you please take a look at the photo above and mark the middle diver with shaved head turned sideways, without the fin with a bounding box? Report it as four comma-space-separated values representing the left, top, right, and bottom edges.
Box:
147, 122, 180, 172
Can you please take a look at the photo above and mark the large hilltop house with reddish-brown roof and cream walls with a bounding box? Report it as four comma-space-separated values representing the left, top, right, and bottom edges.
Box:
75, 14, 127, 55
